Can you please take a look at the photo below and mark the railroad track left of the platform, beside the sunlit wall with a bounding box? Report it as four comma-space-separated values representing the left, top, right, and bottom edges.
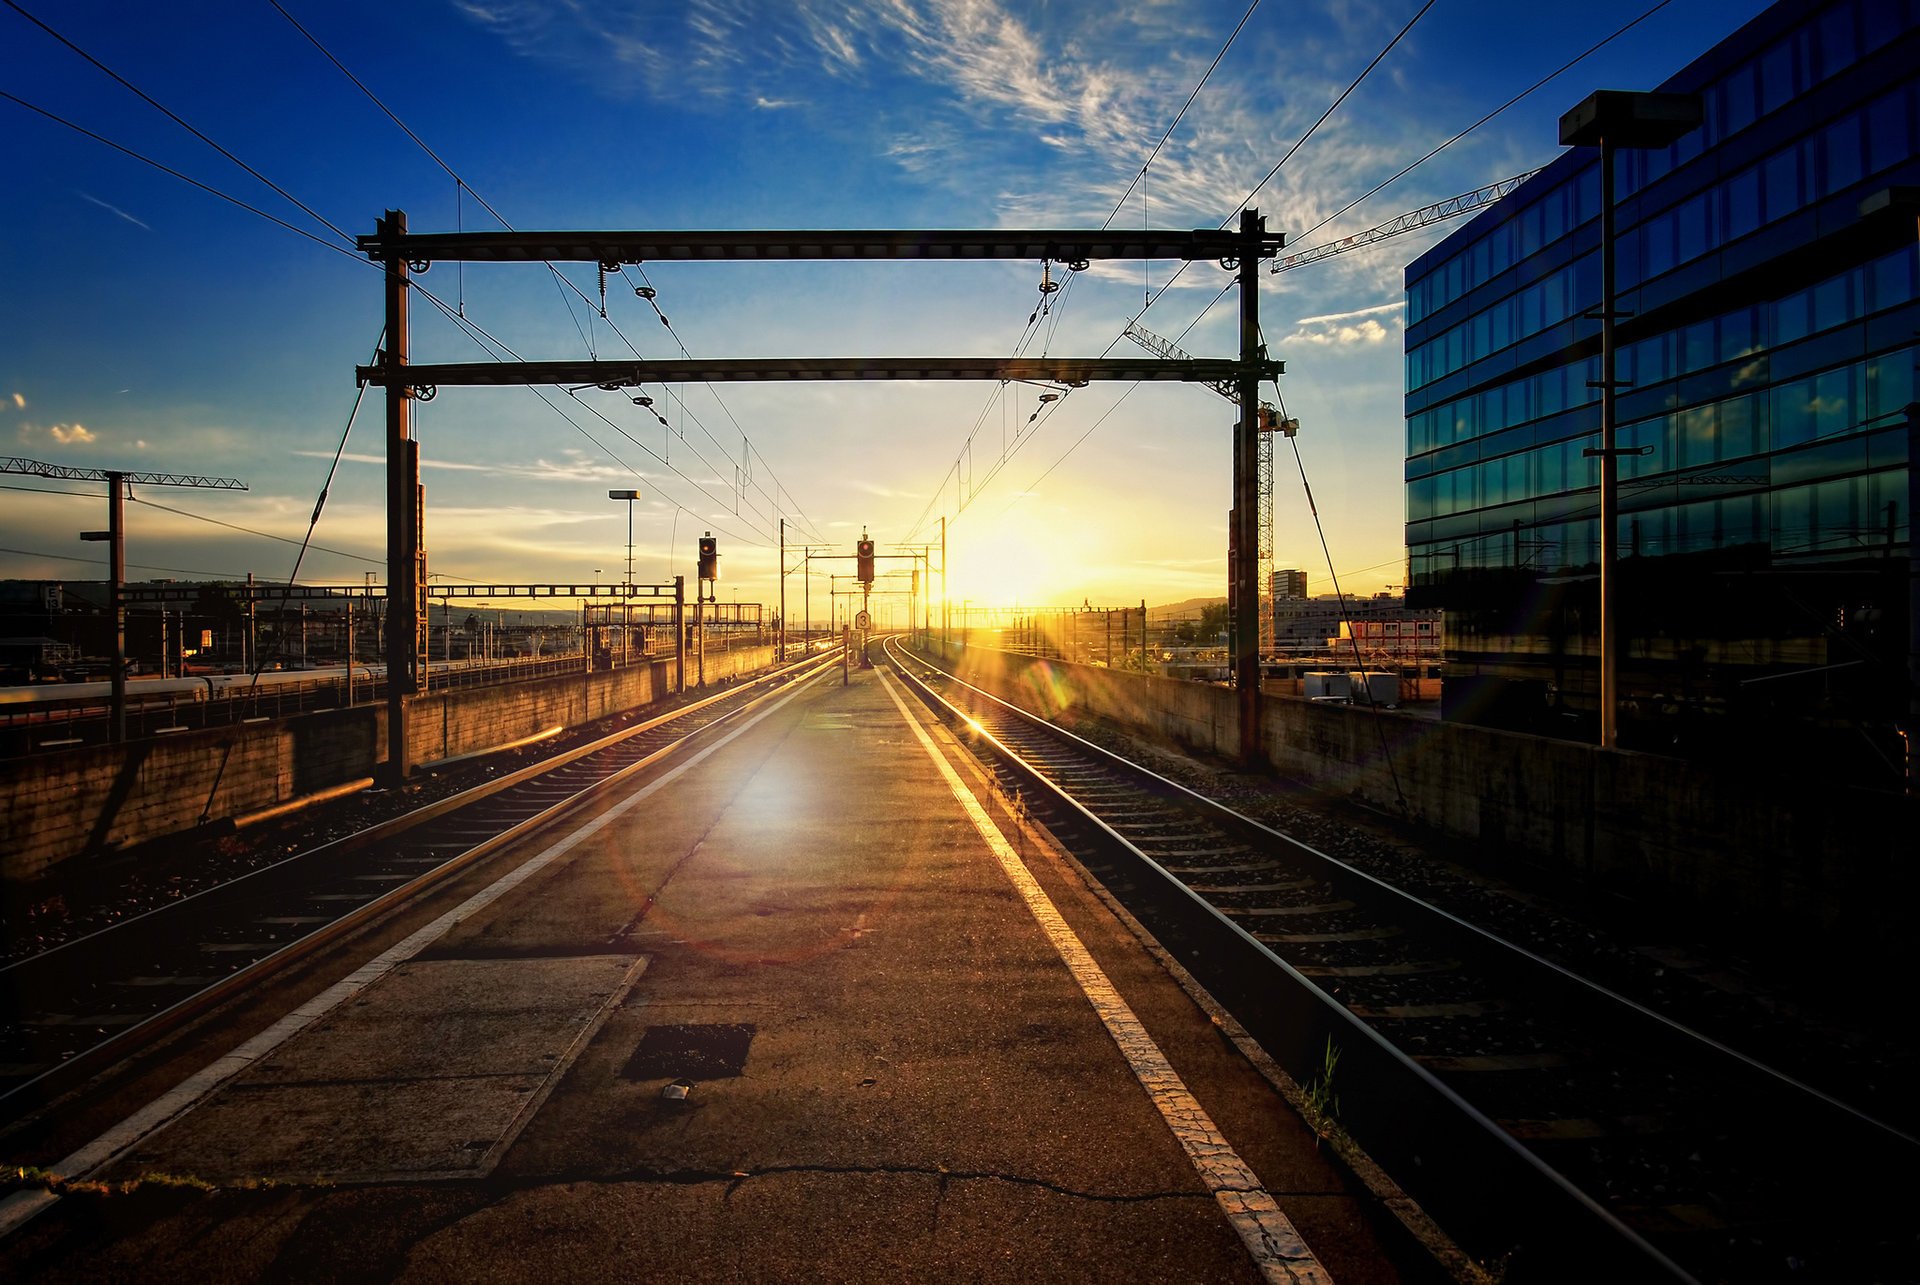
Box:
0, 657, 831, 1122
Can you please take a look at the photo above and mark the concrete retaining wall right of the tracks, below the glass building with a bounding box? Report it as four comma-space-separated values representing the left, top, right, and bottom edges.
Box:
925, 645, 1920, 958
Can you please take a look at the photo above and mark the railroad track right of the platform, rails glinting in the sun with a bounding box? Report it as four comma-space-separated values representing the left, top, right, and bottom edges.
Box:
889, 643, 1920, 1281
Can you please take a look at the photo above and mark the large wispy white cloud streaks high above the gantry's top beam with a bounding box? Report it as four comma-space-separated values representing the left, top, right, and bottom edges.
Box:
455, 0, 1432, 229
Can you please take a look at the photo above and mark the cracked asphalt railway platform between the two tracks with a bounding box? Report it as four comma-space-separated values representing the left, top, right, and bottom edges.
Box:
0, 670, 1400, 1281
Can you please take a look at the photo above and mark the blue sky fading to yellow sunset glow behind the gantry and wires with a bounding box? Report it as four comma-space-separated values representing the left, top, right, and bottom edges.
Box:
0, 0, 1764, 613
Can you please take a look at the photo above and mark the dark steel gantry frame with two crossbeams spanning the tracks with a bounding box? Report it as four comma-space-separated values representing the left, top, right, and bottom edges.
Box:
355, 209, 1286, 780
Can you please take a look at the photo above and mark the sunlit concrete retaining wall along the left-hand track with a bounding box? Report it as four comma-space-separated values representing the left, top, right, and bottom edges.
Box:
0, 647, 774, 885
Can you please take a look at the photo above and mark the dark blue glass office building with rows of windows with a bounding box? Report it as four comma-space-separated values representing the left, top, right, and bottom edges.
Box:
1405, 0, 1920, 780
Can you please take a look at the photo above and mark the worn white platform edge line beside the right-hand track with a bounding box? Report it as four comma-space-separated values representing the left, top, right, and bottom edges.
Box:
876, 670, 1332, 1285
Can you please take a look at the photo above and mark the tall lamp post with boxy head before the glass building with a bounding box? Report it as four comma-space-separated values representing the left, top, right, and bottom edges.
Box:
1561, 88, 1701, 749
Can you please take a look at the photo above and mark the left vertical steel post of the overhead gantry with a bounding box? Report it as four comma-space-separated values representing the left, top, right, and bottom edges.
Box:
376, 209, 420, 784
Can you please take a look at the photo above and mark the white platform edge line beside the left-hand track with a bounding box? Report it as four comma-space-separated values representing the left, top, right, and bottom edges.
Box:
0, 676, 820, 1237
